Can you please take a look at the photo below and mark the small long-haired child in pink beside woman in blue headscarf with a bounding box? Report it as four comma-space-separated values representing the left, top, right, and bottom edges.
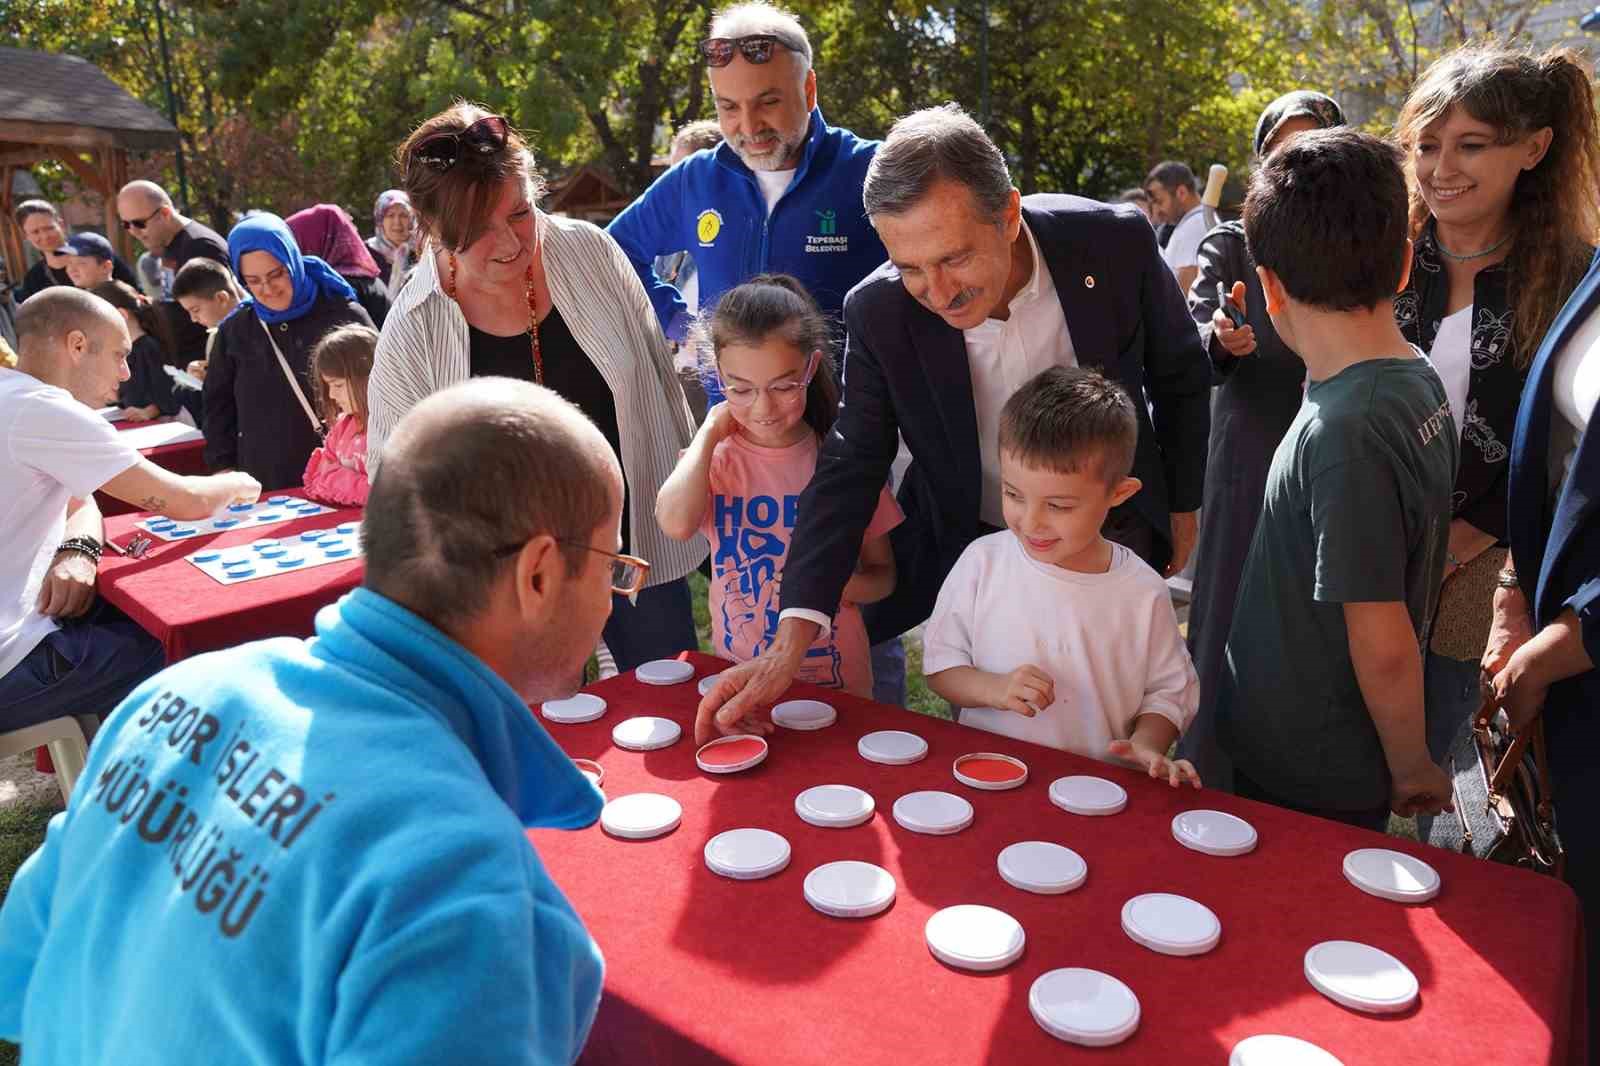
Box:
302, 325, 378, 507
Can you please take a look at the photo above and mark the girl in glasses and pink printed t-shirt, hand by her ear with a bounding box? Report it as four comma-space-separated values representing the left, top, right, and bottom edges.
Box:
656, 274, 904, 698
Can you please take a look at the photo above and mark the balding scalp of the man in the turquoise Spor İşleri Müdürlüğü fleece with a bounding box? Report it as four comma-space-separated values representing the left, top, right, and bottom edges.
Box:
362, 378, 622, 629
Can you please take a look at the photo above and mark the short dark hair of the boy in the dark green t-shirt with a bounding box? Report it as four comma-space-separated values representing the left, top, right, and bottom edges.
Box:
1245, 126, 1410, 311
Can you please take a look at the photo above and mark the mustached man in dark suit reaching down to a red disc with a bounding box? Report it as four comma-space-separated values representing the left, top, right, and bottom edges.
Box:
698, 104, 1211, 736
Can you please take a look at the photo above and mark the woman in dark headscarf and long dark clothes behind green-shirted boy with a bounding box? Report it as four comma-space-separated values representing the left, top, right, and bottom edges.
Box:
1178, 90, 1344, 791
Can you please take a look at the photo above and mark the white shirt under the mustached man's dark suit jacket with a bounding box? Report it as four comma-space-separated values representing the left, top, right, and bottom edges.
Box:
962, 222, 1078, 525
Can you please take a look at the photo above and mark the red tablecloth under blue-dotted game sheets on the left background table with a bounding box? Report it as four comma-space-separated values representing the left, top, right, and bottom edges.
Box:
99, 490, 363, 663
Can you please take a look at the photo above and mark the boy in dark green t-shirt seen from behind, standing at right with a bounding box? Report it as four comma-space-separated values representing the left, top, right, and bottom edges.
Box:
1218, 128, 1459, 831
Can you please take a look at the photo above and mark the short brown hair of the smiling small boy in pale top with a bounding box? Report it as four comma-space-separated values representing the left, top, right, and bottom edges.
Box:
1000, 367, 1139, 485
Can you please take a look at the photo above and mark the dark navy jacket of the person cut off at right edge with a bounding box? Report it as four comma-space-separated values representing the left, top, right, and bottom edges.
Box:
1507, 246, 1600, 765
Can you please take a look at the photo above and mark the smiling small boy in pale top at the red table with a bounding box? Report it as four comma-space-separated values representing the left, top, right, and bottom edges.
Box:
922, 367, 1200, 787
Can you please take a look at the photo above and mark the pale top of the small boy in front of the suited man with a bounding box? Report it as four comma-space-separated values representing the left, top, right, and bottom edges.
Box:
922, 530, 1200, 762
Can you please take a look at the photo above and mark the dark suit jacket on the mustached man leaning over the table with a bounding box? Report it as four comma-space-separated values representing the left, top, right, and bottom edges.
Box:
782, 195, 1211, 642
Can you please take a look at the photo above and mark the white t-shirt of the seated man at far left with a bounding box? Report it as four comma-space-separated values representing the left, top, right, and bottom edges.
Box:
0, 368, 139, 677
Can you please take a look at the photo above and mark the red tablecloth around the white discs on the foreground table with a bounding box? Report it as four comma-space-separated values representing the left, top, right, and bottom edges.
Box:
530, 655, 1584, 1066
